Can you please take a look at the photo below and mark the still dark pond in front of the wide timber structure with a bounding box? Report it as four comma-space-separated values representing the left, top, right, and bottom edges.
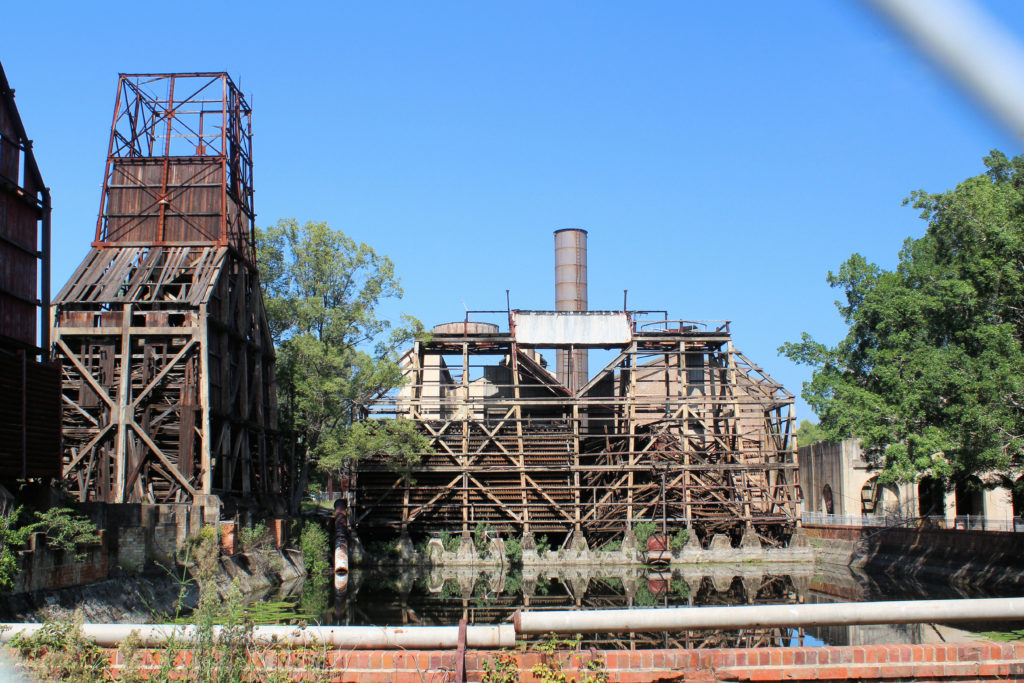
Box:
258, 564, 1020, 648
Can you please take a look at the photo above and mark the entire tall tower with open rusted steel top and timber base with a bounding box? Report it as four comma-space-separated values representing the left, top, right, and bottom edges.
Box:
52, 73, 290, 507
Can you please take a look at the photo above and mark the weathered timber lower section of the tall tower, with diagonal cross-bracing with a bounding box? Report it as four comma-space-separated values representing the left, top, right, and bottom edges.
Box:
52, 247, 287, 503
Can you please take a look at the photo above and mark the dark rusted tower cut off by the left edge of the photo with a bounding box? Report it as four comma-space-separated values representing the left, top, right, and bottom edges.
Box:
0, 61, 60, 483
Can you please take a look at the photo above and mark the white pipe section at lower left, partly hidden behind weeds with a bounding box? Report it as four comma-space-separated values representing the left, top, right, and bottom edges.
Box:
0, 624, 515, 650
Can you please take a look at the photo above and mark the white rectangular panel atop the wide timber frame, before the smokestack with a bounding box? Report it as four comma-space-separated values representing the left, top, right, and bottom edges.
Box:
513, 311, 632, 345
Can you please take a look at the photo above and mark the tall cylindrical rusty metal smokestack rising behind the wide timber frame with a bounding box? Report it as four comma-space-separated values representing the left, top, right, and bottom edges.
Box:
555, 229, 590, 391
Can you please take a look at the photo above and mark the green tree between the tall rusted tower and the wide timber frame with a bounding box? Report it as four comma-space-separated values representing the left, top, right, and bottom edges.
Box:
257, 219, 429, 509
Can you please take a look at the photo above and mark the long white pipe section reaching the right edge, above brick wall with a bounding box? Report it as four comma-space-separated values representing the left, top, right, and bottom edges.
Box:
513, 598, 1024, 635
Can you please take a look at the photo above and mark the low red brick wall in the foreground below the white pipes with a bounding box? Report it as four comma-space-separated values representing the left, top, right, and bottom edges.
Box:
96, 643, 1024, 683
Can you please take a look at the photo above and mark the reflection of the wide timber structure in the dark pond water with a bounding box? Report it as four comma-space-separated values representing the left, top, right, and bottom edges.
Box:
327, 566, 810, 649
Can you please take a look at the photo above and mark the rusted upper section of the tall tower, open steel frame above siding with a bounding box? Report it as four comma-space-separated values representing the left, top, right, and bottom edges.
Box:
95, 74, 255, 263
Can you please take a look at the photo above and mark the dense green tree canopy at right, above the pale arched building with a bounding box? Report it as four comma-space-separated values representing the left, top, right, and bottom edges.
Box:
779, 152, 1024, 480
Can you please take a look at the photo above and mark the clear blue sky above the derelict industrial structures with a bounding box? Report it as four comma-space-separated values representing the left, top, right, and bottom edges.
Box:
0, 0, 1024, 418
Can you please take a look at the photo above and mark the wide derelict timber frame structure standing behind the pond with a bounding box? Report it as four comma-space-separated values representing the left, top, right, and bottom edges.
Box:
350, 310, 798, 547
